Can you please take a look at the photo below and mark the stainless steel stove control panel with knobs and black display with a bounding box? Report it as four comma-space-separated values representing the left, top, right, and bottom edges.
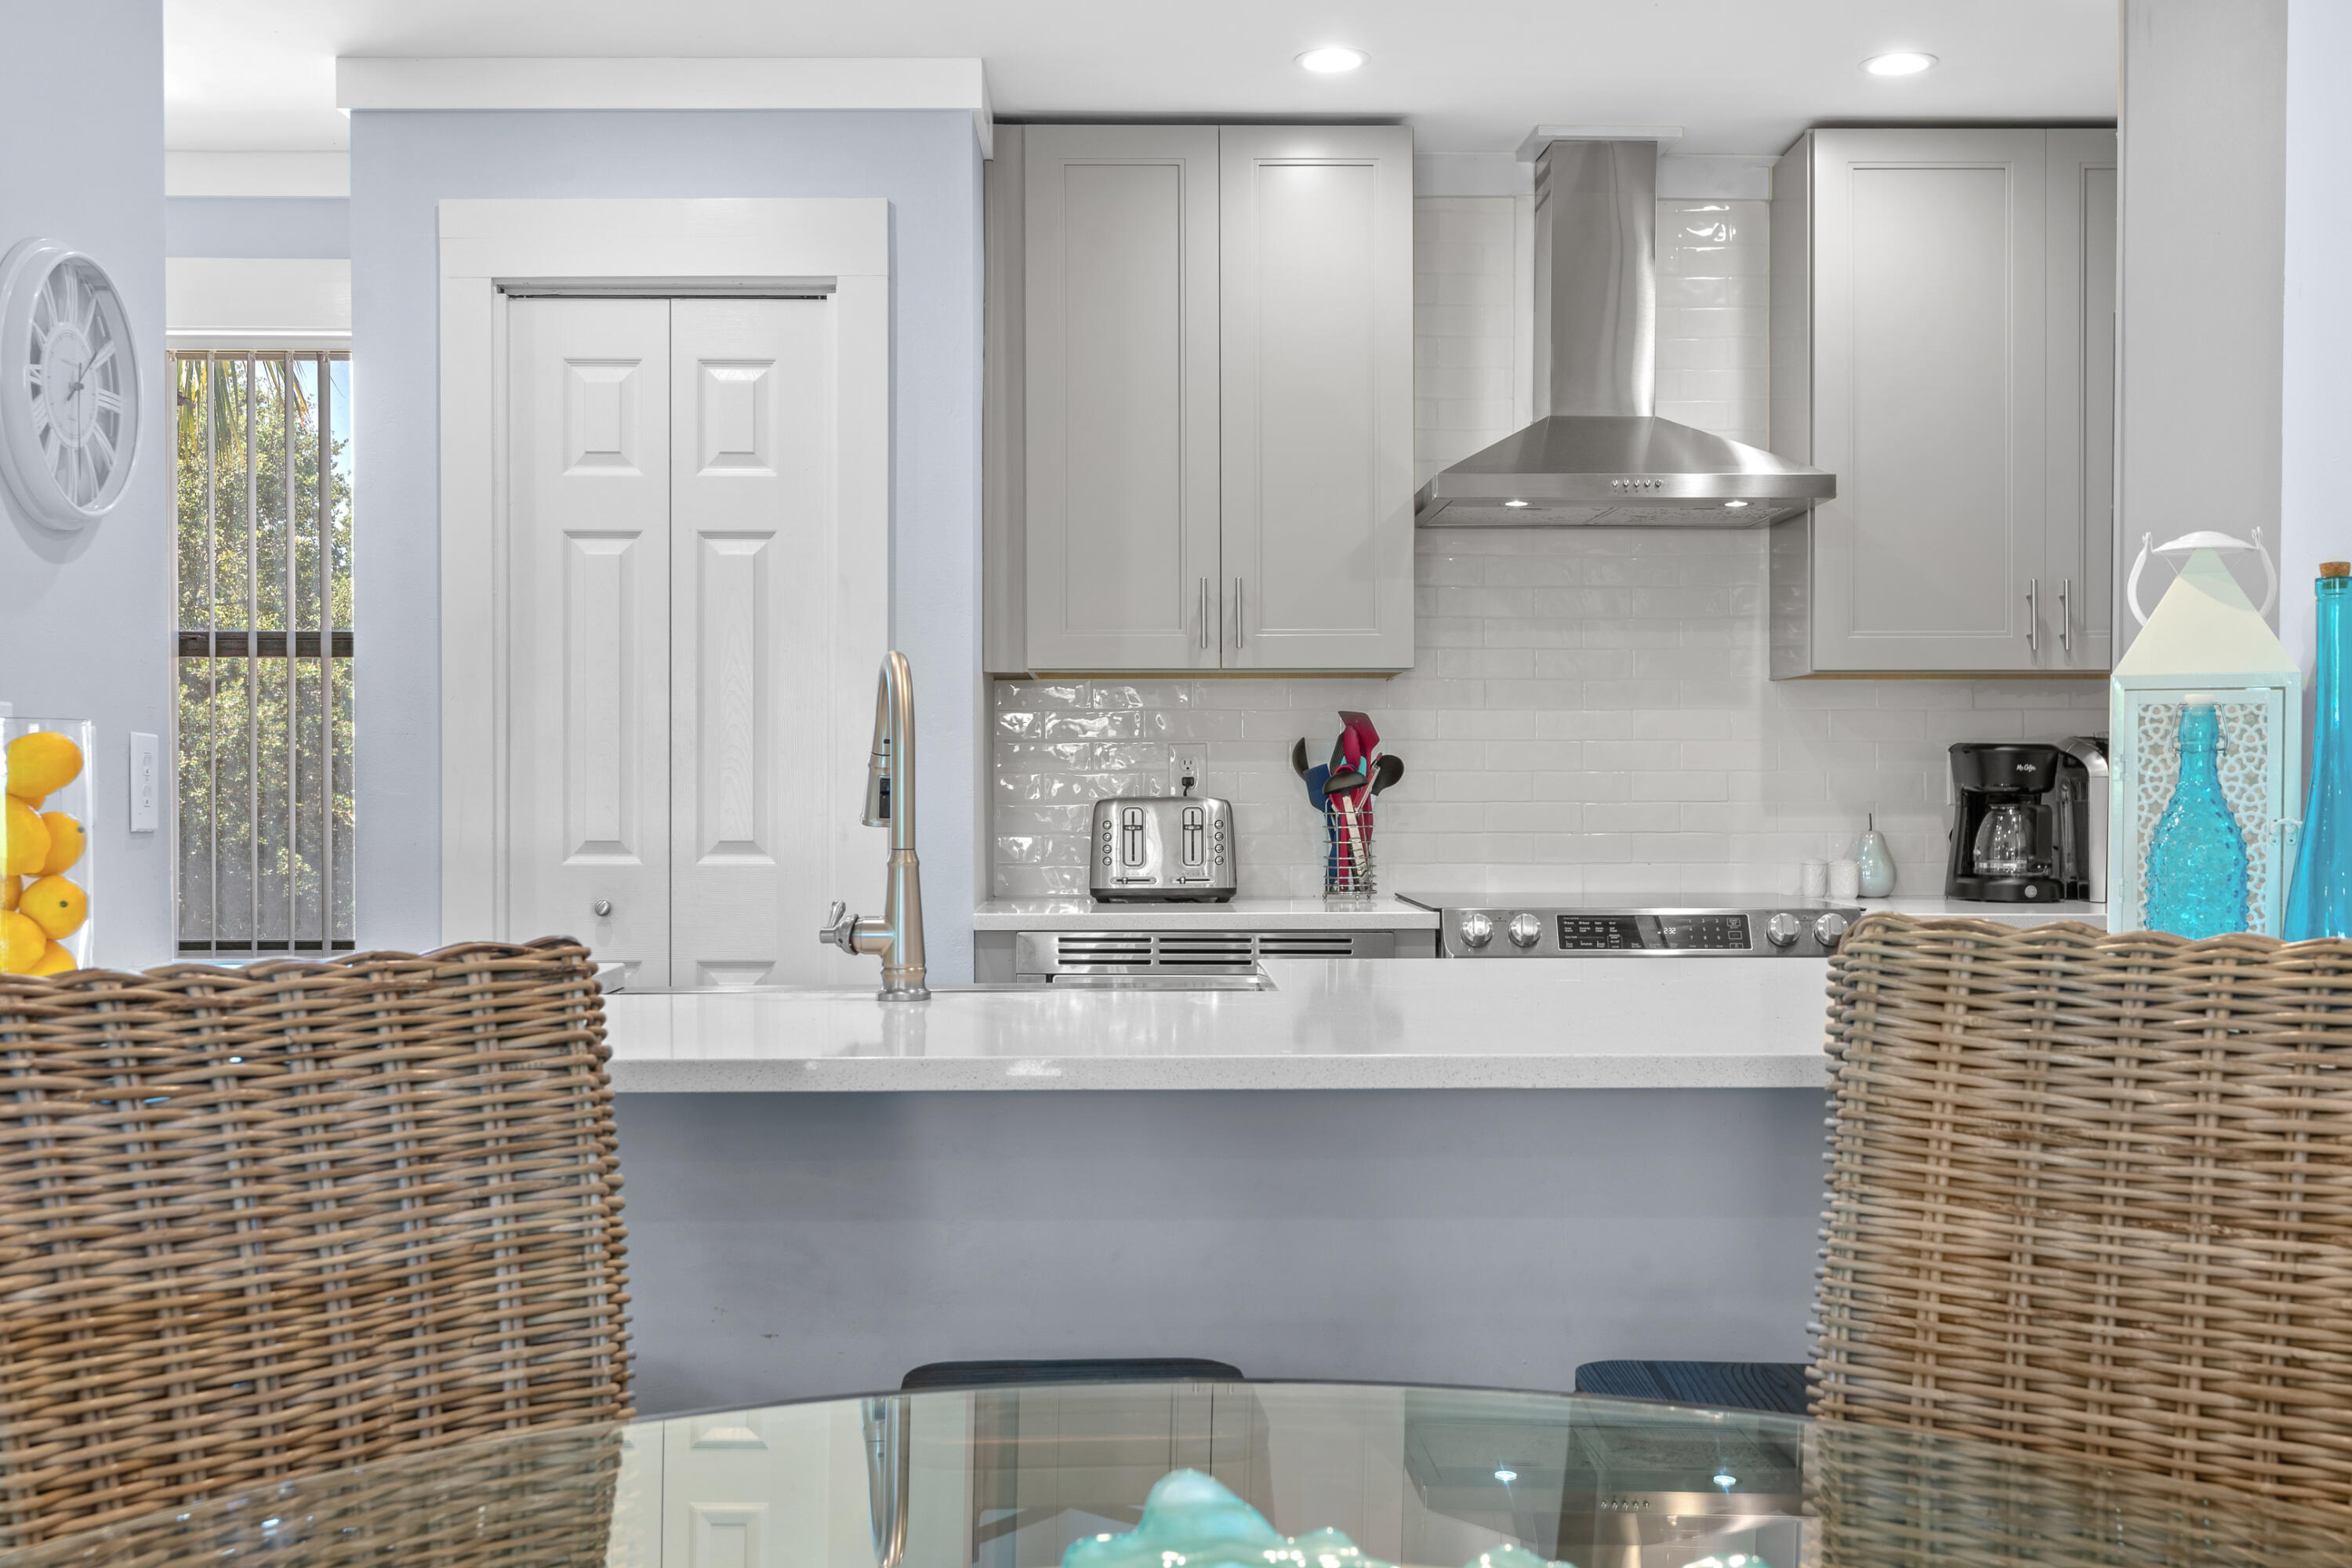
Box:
1437, 905, 1863, 959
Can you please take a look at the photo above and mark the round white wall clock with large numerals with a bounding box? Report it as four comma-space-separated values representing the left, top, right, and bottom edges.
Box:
0, 240, 139, 532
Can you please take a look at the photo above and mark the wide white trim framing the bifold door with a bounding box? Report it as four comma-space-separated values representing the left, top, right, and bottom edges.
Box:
435, 198, 889, 942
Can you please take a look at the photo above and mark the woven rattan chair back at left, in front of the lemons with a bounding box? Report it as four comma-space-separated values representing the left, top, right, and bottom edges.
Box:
0, 938, 628, 1544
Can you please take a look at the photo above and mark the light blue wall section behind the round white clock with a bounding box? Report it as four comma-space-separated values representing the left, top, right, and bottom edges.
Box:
0, 0, 174, 968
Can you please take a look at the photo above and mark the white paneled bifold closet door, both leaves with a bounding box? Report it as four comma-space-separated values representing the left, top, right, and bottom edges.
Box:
510, 299, 861, 987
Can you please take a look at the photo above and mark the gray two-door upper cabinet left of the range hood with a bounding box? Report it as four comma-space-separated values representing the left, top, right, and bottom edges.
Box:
985, 125, 1414, 673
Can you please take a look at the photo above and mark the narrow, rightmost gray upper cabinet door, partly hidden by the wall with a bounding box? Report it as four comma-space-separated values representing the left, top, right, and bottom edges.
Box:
2039, 129, 2117, 673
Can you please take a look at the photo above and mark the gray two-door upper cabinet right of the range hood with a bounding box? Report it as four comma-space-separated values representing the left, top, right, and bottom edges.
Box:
1771, 129, 2114, 677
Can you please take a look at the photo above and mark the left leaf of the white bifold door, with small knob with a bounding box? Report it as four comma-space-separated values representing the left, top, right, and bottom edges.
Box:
506, 299, 670, 985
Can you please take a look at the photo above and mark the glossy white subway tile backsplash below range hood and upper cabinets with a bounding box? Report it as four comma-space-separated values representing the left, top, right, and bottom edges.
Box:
995, 529, 2105, 895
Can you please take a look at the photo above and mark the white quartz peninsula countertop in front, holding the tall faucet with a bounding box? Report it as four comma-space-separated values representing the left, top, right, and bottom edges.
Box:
604, 956, 1828, 1093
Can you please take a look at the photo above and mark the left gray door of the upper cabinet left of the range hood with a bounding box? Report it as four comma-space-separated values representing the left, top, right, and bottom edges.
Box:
1023, 125, 1218, 670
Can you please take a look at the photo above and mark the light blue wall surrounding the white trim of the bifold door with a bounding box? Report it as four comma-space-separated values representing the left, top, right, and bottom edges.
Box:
350, 111, 983, 980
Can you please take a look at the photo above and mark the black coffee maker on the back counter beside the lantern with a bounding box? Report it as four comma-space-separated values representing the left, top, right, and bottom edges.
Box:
1943, 736, 2107, 902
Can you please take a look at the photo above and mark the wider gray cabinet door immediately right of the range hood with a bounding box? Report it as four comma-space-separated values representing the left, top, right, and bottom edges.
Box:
1813, 129, 2053, 670
